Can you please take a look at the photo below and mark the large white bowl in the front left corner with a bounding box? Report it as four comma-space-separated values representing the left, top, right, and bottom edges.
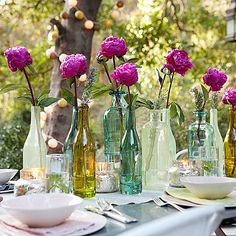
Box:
1, 193, 83, 227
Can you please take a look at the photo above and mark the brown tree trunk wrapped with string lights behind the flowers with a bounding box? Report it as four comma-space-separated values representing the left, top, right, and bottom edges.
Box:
44, 0, 101, 153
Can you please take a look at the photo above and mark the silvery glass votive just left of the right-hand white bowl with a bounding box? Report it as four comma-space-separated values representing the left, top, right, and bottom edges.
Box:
168, 160, 199, 188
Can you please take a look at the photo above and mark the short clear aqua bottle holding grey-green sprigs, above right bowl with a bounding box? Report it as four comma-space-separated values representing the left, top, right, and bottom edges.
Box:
188, 111, 218, 176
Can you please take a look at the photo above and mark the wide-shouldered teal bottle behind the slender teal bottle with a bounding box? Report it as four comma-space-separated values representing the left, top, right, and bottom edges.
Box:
103, 91, 127, 169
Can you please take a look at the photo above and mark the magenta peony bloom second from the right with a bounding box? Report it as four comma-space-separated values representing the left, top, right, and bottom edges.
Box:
203, 68, 227, 91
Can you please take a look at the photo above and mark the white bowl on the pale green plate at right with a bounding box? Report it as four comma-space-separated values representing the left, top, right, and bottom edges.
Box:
180, 176, 236, 199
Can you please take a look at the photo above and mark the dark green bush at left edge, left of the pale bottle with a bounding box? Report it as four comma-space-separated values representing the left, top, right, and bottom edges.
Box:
0, 111, 29, 170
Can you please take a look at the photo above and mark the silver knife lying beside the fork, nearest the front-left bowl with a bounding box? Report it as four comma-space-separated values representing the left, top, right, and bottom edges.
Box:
84, 206, 138, 224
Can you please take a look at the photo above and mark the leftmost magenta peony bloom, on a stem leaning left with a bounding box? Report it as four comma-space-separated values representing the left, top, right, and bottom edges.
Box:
4, 46, 33, 72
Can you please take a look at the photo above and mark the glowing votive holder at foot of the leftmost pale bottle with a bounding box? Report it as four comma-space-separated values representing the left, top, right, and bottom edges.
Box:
14, 168, 46, 196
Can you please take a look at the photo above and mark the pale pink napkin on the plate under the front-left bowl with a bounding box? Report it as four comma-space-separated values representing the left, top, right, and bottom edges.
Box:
0, 215, 94, 236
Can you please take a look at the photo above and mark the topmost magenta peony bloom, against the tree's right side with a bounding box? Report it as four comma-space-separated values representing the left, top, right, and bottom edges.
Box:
99, 36, 127, 59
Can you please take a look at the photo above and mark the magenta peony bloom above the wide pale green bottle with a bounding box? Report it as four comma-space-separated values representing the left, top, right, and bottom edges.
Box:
165, 49, 193, 76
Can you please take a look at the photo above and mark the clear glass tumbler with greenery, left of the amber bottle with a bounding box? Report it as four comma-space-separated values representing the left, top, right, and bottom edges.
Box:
46, 154, 70, 193
